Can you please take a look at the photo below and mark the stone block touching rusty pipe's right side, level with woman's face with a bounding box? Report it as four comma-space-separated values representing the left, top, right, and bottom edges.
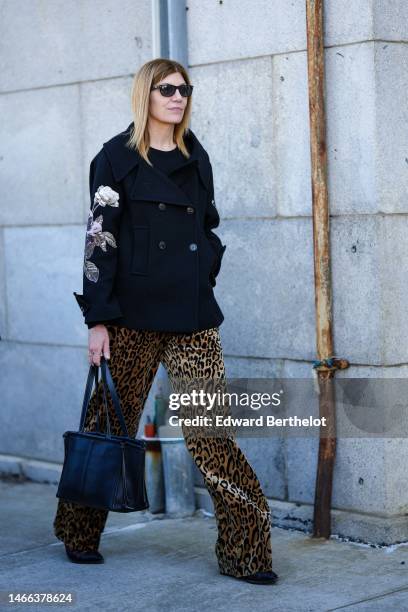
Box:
318, 41, 381, 215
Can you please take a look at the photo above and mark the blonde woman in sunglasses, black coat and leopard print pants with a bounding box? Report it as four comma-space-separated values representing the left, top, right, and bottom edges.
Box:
54, 58, 277, 584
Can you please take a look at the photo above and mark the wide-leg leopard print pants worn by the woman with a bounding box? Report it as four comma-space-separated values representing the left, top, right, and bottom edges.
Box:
53, 325, 272, 577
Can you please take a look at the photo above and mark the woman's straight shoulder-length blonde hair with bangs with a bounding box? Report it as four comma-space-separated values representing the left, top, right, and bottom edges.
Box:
126, 57, 192, 166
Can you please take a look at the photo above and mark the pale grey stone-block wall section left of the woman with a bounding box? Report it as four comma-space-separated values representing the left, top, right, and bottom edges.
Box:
0, 0, 154, 462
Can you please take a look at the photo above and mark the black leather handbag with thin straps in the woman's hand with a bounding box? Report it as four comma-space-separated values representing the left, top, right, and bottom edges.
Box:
56, 357, 149, 512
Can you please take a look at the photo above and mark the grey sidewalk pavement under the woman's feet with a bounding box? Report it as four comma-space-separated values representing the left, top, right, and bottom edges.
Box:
0, 480, 408, 612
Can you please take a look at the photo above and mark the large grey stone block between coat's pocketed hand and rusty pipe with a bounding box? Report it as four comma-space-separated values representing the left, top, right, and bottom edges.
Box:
217, 219, 315, 360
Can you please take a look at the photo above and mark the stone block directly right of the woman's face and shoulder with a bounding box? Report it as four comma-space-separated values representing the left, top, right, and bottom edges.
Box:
191, 57, 278, 217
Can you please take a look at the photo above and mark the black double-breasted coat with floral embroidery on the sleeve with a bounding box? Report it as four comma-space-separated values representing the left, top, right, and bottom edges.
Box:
74, 123, 226, 333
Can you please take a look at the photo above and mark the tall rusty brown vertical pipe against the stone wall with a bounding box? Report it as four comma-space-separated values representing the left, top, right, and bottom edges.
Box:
306, 0, 349, 538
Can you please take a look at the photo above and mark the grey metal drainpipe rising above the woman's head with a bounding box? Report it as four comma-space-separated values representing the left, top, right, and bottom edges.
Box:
152, 0, 188, 68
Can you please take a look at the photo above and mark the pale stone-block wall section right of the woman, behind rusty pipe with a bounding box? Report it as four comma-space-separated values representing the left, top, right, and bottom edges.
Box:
188, 0, 408, 542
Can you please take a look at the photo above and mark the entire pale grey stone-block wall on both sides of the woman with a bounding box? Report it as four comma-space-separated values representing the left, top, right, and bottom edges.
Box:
0, 0, 408, 541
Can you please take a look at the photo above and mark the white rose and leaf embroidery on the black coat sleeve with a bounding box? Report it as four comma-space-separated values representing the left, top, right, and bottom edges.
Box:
84, 185, 119, 283
